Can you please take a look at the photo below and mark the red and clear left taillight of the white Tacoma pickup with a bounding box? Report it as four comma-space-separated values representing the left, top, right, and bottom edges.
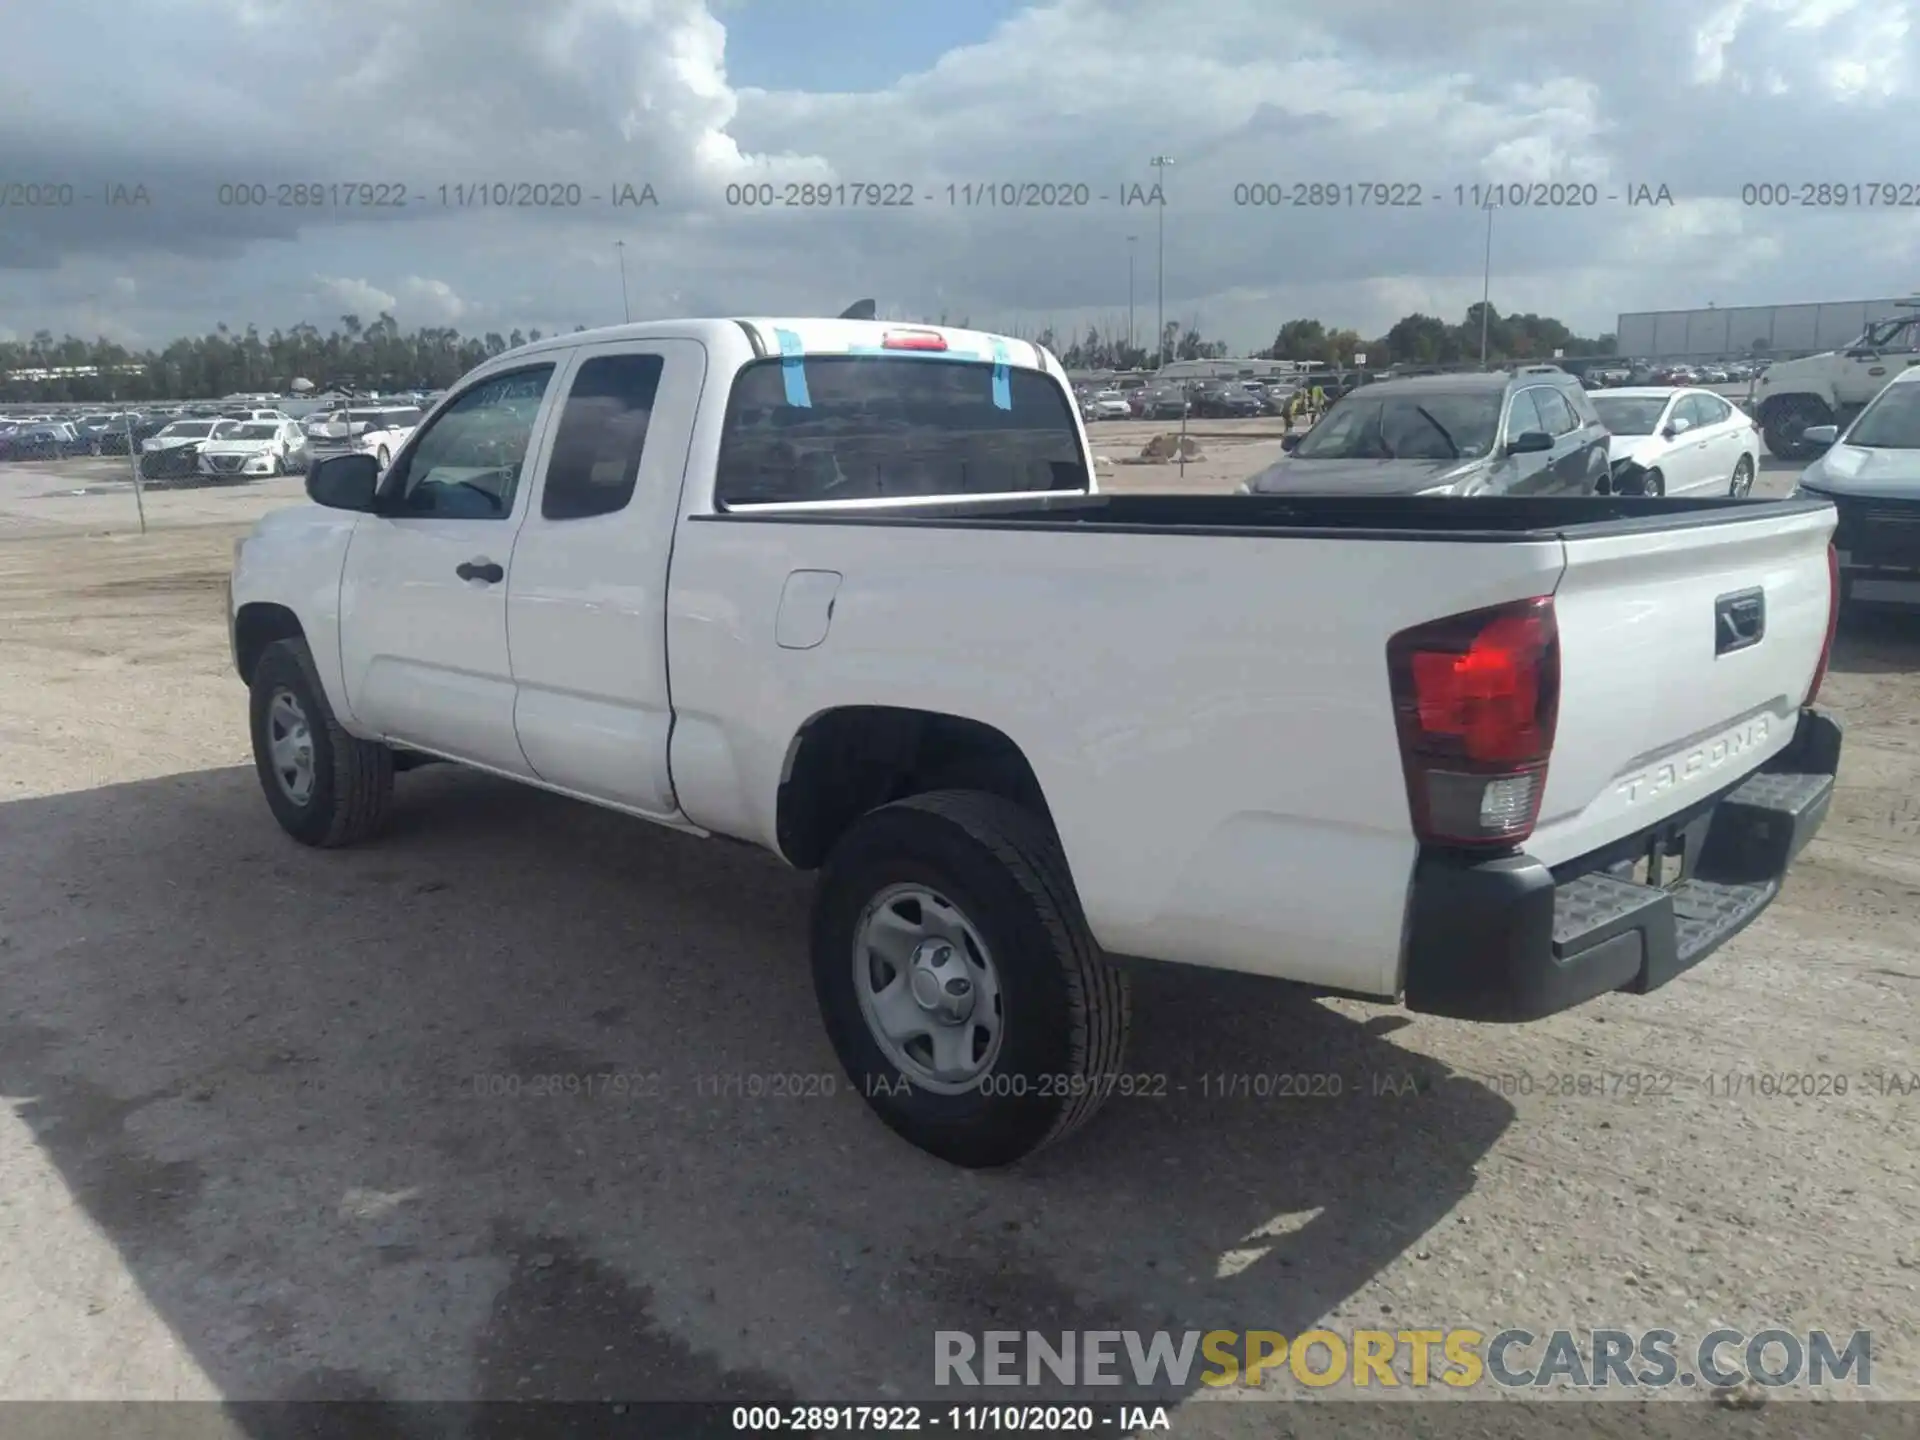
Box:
1386, 595, 1559, 847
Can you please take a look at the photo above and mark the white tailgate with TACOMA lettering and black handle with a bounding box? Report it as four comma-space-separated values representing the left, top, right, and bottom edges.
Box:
1526, 507, 1834, 866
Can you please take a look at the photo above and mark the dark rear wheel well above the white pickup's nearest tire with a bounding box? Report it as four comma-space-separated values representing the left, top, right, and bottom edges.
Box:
776, 705, 1052, 870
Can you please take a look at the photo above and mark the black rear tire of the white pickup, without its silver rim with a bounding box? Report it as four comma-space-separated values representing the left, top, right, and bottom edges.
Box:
812, 789, 1131, 1169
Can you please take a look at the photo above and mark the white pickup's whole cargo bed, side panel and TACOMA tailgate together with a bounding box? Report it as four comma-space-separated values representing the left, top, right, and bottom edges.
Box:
668, 493, 1834, 995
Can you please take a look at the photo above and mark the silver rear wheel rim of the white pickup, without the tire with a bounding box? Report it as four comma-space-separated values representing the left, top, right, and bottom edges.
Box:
852, 885, 1002, 1094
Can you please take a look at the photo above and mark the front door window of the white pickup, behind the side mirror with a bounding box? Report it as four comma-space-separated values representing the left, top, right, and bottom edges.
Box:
382, 365, 553, 520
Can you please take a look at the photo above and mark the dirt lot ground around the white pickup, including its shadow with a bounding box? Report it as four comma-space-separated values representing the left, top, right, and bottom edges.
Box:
0, 445, 1920, 1434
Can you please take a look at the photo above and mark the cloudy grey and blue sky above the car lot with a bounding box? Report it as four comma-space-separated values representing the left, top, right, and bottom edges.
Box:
0, 0, 1920, 348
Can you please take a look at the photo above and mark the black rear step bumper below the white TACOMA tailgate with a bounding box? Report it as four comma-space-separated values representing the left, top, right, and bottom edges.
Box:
1405, 710, 1841, 1021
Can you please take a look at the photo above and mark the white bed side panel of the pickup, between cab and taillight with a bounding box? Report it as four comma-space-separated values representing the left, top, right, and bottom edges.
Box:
668, 516, 1563, 995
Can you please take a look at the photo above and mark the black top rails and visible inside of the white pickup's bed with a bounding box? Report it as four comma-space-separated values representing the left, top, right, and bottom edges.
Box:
710, 493, 1826, 543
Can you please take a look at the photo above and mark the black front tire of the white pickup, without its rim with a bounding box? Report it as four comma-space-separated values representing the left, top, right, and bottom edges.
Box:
250, 639, 394, 849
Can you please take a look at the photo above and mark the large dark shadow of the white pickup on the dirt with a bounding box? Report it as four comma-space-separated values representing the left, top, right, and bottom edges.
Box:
0, 768, 1513, 1436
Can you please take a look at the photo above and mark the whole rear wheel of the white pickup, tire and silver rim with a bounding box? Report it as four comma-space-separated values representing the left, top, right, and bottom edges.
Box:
812, 789, 1131, 1167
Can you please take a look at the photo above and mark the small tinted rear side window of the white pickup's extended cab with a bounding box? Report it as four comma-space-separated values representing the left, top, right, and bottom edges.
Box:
540, 355, 666, 520
